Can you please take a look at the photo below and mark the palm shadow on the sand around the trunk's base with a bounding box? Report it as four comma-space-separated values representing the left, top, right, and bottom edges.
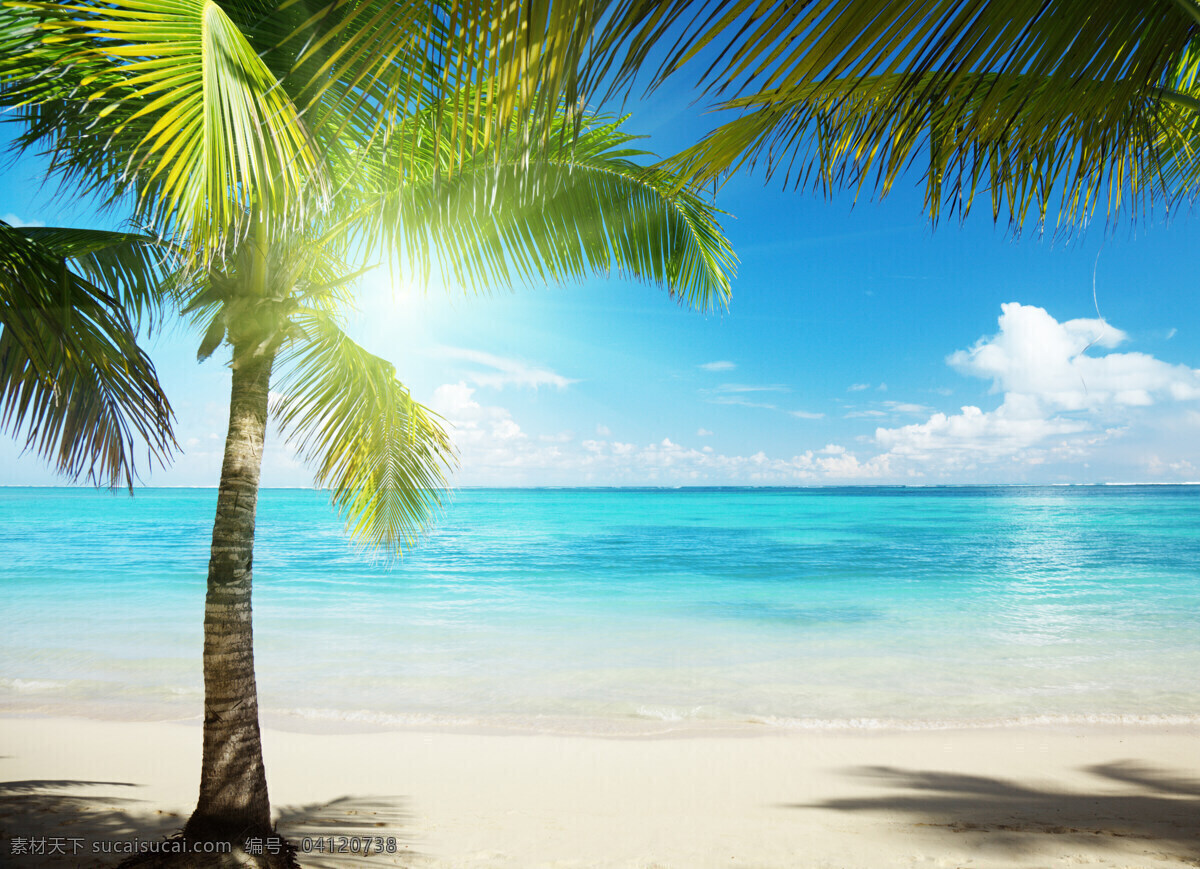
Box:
0, 779, 420, 869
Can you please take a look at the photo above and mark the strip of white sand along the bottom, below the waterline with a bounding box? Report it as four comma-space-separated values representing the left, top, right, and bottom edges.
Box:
0, 719, 1200, 869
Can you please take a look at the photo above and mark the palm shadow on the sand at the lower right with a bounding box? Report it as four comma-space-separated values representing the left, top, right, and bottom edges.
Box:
784, 760, 1200, 867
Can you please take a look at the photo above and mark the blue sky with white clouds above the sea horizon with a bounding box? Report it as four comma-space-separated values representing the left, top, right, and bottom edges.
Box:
0, 78, 1200, 486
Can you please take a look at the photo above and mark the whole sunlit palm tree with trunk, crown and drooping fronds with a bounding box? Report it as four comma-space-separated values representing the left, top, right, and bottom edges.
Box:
0, 0, 733, 859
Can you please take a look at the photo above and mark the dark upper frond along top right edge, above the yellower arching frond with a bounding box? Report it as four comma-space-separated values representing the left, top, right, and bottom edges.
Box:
604, 0, 1198, 103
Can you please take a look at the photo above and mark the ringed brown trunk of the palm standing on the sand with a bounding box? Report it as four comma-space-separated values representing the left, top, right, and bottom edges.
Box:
184, 341, 275, 845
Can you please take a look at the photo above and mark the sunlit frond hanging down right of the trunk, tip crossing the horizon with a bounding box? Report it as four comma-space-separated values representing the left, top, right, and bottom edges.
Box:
272, 311, 455, 553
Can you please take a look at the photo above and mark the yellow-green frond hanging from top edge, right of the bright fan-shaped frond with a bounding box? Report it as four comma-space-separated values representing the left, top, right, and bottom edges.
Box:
278, 0, 611, 174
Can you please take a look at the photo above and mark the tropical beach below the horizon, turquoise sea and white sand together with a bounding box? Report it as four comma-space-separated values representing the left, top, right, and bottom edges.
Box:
0, 486, 1200, 869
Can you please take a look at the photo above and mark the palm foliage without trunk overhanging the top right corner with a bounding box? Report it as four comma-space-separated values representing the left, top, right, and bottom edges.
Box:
597, 0, 1200, 230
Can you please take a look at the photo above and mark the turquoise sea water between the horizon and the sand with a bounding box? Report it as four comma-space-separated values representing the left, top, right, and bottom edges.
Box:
0, 486, 1200, 732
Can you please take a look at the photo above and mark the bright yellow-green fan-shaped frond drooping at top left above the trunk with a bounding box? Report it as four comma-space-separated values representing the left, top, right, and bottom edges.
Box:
14, 0, 324, 256
